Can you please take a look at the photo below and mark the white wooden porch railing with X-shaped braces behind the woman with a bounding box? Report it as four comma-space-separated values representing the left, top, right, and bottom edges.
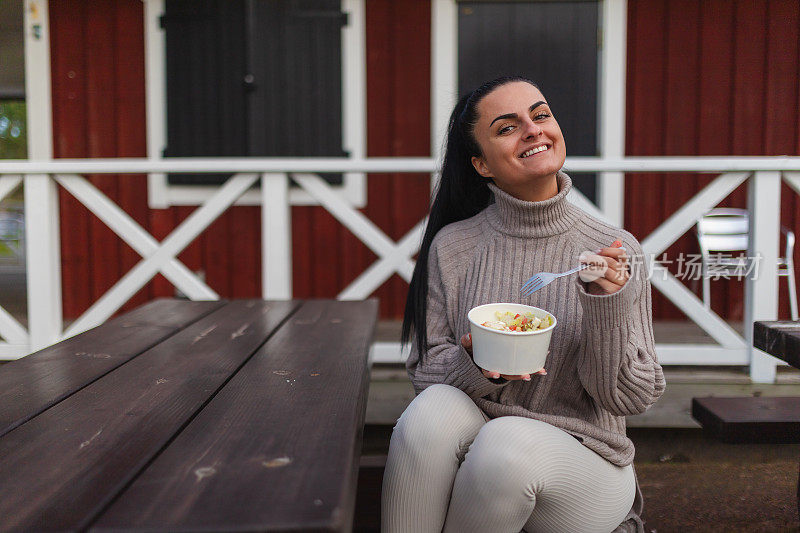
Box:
0, 157, 800, 382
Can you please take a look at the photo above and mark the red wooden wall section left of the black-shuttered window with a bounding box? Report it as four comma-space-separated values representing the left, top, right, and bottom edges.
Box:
50, 0, 157, 318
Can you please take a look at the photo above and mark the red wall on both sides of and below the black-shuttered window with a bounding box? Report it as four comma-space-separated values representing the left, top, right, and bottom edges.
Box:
50, 0, 430, 318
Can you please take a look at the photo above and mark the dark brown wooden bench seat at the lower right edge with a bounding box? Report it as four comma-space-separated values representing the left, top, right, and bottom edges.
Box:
692, 396, 800, 444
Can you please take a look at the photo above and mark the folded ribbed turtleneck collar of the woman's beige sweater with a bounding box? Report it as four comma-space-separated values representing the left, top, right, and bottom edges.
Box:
486, 171, 581, 237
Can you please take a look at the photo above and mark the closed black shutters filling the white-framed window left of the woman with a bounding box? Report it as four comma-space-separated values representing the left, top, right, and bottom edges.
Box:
164, 0, 346, 187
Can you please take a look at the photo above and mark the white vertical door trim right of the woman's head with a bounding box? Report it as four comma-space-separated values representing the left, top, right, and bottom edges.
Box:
597, 0, 628, 227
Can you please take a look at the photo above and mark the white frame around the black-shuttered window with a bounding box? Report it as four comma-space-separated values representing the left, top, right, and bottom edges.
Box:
143, 0, 367, 209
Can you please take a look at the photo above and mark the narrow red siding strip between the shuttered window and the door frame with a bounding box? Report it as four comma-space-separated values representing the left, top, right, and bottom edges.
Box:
366, 0, 431, 317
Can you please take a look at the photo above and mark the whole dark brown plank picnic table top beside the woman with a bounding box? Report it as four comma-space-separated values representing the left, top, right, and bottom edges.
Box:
0, 300, 377, 531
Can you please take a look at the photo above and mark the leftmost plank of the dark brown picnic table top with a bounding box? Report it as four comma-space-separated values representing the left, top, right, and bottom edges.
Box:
0, 300, 223, 436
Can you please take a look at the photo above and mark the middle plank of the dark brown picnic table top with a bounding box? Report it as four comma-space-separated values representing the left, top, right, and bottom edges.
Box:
0, 301, 298, 531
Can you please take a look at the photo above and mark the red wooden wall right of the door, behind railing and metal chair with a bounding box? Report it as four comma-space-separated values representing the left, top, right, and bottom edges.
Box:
625, 0, 800, 320
